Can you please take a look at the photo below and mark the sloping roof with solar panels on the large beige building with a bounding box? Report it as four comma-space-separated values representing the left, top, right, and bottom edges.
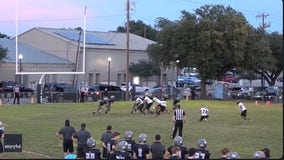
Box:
34, 28, 156, 51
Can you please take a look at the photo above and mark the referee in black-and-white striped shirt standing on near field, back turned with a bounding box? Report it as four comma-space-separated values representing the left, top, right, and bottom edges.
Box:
172, 104, 186, 139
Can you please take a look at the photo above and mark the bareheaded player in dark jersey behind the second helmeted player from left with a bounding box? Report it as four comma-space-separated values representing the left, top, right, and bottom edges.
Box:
106, 132, 120, 160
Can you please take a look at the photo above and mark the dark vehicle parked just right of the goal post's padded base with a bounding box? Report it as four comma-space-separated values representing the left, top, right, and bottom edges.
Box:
43, 83, 78, 103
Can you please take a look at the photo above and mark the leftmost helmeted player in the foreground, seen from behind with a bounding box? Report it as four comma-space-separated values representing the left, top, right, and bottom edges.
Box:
84, 137, 101, 160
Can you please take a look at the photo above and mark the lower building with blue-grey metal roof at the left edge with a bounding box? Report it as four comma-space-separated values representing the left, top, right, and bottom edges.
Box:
0, 38, 75, 86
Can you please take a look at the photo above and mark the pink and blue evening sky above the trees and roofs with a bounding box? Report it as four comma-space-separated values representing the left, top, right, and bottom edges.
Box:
0, 0, 283, 37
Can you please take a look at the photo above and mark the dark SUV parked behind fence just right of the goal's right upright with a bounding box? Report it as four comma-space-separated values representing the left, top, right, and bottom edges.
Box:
87, 84, 126, 101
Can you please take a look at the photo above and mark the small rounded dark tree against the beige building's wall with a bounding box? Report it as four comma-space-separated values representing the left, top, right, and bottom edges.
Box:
129, 60, 160, 85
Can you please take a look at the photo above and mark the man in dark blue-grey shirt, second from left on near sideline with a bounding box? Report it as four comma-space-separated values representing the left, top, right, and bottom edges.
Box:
72, 123, 92, 159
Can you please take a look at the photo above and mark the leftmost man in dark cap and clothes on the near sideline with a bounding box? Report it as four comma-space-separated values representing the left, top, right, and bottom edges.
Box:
56, 119, 76, 156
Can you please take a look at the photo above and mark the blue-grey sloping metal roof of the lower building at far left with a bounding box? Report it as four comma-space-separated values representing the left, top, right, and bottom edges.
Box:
0, 38, 71, 64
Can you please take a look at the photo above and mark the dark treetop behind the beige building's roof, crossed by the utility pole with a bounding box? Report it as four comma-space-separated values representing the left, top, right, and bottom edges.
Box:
117, 20, 157, 41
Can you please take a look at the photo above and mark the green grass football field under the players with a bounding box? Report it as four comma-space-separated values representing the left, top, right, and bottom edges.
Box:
0, 100, 283, 159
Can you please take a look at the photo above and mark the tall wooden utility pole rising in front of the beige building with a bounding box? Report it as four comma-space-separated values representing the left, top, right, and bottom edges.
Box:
126, 0, 130, 101
